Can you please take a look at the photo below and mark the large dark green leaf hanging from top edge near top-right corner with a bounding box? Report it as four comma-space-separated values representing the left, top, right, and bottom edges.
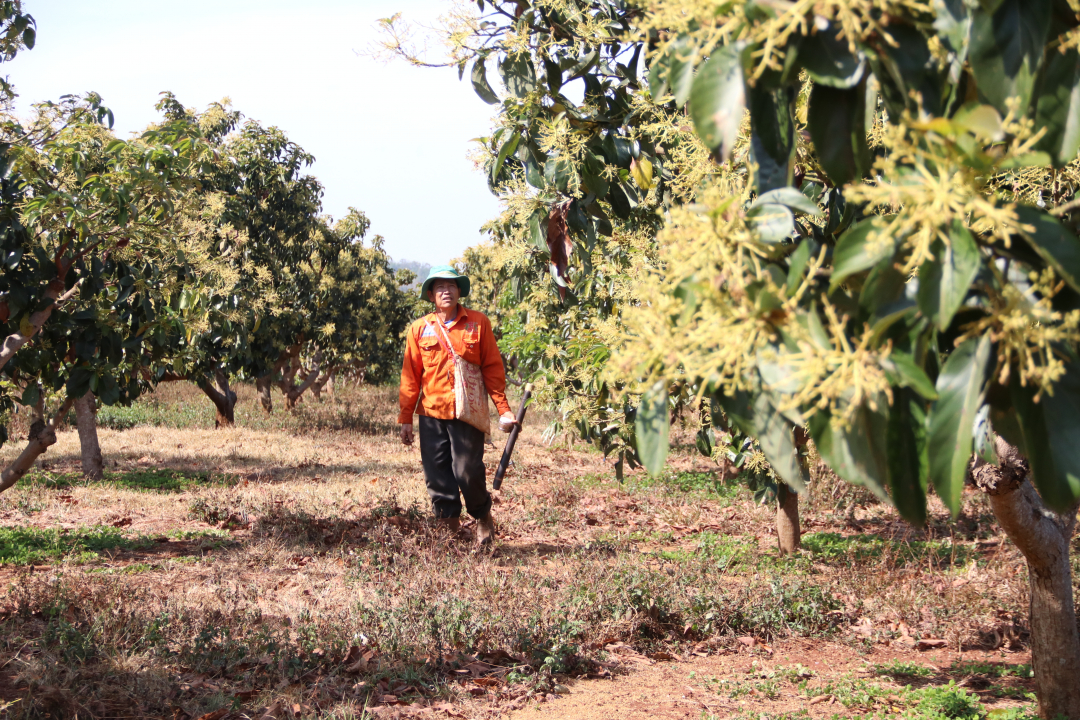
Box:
969, 0, 1051, 114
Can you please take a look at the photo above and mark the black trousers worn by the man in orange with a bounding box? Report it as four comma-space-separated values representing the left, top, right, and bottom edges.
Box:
418, 415, 491, 518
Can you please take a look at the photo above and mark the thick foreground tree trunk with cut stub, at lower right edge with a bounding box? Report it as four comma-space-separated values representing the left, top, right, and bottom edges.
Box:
972, 437, 1080, 720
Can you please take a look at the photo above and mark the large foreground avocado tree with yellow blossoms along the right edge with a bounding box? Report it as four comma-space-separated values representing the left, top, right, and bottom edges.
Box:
612, 0, 1080, 718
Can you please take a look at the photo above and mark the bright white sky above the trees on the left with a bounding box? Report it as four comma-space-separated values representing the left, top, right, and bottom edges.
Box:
0, 0, 499, 263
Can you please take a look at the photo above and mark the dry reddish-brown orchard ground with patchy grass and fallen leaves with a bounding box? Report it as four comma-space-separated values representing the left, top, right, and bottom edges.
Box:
0, 386, 1049, 720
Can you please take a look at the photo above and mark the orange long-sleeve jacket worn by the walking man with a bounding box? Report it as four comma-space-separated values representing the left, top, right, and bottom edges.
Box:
397, 304, 511, 425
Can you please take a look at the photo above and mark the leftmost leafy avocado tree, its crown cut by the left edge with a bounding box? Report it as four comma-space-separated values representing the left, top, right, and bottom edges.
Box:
0, 88, 214, 483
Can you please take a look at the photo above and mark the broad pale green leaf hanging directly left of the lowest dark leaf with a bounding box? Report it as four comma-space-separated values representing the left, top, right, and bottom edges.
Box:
809, 397, 892, 504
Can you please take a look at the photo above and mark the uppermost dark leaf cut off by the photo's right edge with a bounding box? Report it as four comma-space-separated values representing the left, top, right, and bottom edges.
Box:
1035, 47, 1080, 167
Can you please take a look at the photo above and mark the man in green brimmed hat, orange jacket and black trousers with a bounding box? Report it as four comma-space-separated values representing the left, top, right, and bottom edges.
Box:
397, 266, 514, 545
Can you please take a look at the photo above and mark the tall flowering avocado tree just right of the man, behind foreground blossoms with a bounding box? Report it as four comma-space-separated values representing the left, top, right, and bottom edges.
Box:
383, 0, 711, 478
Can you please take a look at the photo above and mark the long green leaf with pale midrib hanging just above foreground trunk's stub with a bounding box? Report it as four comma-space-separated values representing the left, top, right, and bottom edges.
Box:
927, 336, 990, 517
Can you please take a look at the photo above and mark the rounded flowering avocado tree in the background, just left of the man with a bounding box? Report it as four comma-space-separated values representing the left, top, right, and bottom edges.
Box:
160, 94, 414, 426
